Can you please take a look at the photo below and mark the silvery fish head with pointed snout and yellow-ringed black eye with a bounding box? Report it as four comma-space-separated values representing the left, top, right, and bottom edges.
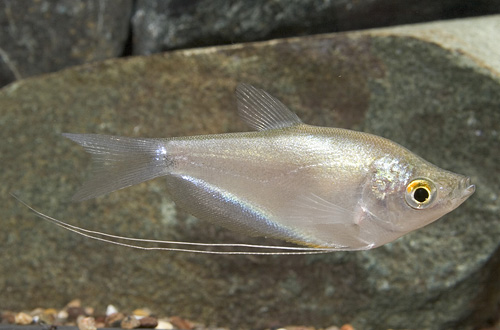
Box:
365, 154, 475, 236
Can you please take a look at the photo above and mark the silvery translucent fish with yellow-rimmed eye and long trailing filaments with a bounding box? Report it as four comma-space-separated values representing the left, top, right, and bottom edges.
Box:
12, 83, 475, 253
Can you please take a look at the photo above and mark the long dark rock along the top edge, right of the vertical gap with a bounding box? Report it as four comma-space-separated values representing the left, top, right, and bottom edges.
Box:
132, 0, 500, 54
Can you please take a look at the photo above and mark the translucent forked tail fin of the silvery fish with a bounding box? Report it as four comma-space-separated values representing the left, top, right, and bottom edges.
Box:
63, 133, 168, 201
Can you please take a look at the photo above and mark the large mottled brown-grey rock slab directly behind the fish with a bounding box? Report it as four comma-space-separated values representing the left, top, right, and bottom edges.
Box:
0, 16, 500, 329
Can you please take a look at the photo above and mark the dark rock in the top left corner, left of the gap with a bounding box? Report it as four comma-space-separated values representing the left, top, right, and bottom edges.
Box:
0, 0, 132, 86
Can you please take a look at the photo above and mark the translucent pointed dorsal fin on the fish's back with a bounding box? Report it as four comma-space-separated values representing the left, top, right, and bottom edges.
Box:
236, 83, 302, 131
